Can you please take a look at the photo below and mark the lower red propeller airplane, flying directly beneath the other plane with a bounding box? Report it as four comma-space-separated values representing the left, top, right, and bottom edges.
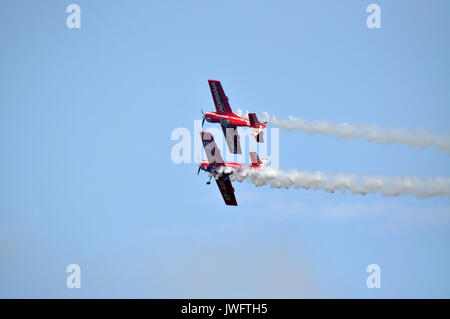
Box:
197, 132, 267, 206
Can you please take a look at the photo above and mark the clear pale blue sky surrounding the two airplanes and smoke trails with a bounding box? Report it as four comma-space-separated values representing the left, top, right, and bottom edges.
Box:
0, 0, 450, 298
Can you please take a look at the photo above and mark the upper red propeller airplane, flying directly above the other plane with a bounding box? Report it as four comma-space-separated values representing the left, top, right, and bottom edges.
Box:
202, 80, 267, 154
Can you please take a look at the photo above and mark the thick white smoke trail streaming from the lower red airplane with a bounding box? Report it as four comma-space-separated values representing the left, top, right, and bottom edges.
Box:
218, 167, 450, 198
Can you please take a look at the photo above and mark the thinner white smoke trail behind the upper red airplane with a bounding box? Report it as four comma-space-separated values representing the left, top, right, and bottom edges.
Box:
263, 113, 450, 155
